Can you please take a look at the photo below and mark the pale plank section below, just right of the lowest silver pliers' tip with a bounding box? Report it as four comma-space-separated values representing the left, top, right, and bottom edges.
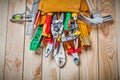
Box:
60, 54, 79, 80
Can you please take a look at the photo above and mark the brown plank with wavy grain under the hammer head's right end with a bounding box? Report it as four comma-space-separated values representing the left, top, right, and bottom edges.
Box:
98, 0, 118, 80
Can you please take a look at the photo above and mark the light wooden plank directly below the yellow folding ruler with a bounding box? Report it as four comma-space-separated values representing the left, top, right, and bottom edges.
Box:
80, 27, 99, 80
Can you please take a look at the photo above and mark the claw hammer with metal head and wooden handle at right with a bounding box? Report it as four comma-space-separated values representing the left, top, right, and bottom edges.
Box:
78, 0, 112, 26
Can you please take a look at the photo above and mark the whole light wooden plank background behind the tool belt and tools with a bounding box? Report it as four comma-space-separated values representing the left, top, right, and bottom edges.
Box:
0, 0, 120, 80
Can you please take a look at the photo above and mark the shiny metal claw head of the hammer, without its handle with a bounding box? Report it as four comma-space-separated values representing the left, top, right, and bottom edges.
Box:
78, 13, 112, 26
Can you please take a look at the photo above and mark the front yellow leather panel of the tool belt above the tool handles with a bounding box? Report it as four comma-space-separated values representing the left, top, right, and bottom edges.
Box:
38, 0, 81, 13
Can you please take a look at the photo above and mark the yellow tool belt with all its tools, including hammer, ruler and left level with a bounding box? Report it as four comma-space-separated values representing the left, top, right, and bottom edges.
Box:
11, 0, 112, 67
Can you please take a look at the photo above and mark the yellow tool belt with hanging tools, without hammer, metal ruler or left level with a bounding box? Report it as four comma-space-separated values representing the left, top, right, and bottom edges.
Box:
31, 0, 91, 67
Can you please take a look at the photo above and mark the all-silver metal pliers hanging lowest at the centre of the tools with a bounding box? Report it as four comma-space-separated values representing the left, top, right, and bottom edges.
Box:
51, 13, 66, 67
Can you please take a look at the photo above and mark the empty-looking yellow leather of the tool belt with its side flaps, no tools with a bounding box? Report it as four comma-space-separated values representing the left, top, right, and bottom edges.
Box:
38, 0, 89, 25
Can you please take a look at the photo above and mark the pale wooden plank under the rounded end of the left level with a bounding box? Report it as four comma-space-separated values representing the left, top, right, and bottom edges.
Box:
4, 0, 25, 80
